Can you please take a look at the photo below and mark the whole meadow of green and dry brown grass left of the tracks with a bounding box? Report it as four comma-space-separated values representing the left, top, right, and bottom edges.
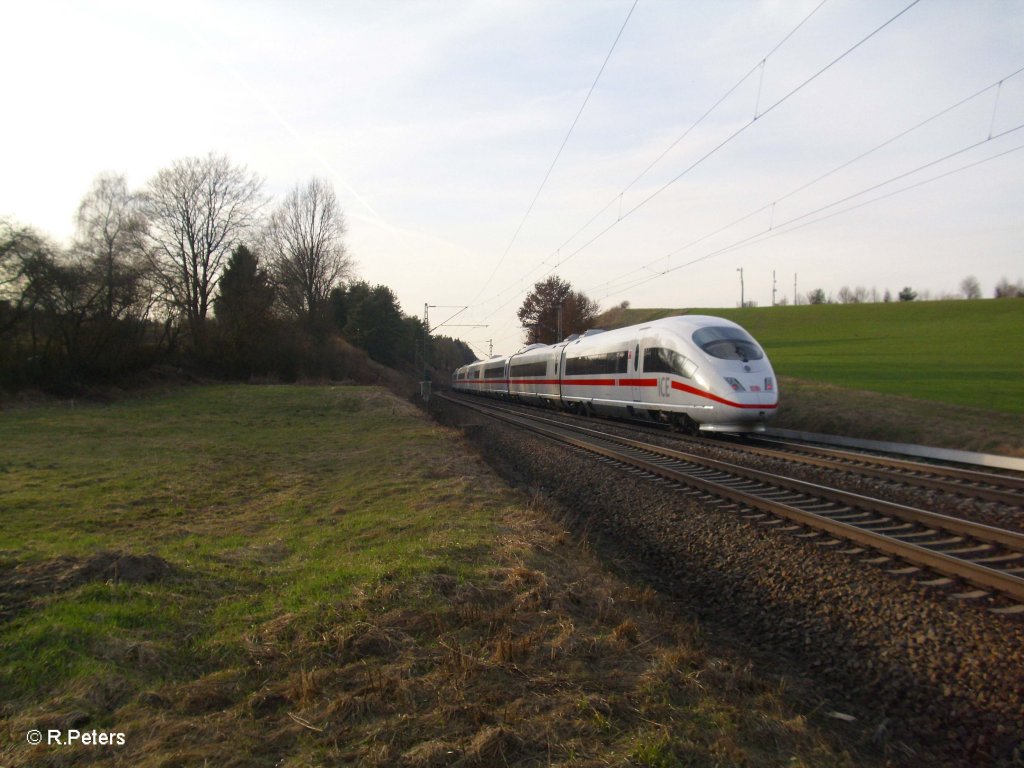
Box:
0, 386, 863, 767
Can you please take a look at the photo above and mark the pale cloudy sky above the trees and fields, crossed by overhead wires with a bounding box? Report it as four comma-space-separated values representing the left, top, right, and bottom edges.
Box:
0, 0, 1024, 355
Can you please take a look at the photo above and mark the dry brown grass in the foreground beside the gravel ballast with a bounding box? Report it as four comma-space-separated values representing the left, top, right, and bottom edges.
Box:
7, 495, 868, 768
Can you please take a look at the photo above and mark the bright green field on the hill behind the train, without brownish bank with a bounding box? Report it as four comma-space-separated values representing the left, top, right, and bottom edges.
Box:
607, 300, 1024, 414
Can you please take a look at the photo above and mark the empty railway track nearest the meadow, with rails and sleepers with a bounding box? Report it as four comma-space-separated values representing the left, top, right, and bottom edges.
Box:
440, 395, 1024, 613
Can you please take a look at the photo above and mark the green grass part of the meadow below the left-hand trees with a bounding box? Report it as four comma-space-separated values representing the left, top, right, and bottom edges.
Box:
0, 386, 494, 702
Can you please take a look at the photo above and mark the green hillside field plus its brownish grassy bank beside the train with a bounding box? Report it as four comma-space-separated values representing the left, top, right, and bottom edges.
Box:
599, 300, 1024, 455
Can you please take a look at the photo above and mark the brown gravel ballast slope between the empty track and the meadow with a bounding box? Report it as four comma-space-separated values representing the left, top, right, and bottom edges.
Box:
432, 393, 1024, 766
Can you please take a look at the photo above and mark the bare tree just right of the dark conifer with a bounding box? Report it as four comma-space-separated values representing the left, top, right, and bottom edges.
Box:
264, 178, 352, 325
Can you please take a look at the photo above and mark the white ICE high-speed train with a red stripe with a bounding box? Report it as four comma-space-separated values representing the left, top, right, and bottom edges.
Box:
452, 315, 778, 434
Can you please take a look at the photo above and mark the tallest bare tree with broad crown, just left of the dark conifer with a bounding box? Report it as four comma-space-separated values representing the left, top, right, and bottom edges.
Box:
144, 154, 263, 350
